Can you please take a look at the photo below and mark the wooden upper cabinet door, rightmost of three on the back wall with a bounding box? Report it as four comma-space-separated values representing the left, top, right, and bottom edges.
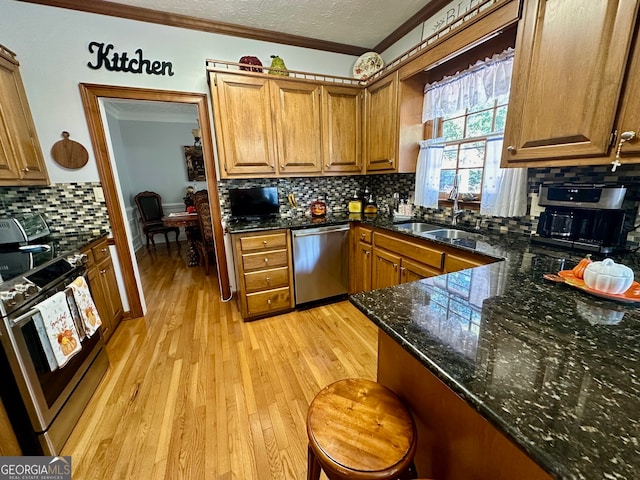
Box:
322, 85, 363, 173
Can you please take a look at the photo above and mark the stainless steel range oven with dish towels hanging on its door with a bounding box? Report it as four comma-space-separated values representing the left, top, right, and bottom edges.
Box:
0, 216, 109, 455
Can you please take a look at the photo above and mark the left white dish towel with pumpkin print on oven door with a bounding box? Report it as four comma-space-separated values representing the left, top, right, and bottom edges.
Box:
33, 292, 82, 370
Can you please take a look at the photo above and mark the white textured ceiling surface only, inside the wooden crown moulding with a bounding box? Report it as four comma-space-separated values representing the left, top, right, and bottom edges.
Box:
101, 0, 429, 49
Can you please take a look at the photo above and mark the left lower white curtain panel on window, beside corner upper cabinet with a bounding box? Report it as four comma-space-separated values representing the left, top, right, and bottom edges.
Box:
414, 139, 444, 208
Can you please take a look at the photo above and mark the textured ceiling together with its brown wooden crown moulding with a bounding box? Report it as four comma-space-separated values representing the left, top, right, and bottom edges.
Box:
19, 0, 452, 55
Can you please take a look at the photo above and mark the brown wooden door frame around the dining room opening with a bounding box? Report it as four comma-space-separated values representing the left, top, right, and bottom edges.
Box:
79, 83, 231, 318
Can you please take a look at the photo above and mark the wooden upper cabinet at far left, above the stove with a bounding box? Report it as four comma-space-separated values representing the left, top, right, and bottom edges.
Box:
0, 45, 49, 185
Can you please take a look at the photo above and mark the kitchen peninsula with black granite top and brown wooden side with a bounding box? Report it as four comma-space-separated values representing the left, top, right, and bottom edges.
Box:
351, 231, 640, 480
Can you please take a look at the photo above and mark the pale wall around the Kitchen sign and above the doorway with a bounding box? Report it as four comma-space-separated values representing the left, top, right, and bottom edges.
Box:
0, 0, 355, 183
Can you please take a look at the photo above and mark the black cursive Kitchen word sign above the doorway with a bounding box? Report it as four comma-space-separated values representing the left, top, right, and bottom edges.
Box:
87, 42, 173, 77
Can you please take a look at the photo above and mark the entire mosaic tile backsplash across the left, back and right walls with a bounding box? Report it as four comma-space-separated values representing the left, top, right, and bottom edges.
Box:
0, 165, 640, 247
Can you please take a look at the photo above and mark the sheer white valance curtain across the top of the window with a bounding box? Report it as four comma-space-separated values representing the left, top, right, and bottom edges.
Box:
422, 48, 513, 123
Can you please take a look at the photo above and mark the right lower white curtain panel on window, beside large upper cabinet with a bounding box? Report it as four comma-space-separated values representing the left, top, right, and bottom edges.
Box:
480, 136, 527, 217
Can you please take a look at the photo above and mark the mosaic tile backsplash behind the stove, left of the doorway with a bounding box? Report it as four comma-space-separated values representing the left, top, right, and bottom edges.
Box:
0, 182, 109, 232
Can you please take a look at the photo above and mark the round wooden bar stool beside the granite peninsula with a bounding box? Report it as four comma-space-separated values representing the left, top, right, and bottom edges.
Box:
307, 378, 417, 480
